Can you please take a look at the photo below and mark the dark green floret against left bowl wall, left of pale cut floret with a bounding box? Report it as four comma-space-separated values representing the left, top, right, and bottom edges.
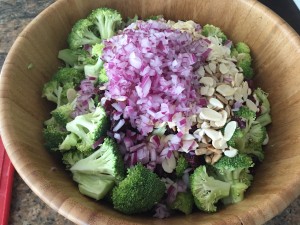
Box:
43, 120, 68, 151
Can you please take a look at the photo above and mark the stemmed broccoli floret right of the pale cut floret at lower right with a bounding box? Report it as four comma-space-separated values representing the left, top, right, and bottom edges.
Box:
213, 153, 254, 204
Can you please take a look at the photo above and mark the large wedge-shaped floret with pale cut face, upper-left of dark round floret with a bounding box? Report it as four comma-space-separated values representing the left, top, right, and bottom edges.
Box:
70, 138, 125, 184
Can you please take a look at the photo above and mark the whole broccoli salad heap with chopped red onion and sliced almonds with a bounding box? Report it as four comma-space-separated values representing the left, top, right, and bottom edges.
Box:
42, 8, 271, 218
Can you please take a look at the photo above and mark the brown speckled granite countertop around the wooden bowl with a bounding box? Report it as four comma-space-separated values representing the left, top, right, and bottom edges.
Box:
0, 0, 300, 225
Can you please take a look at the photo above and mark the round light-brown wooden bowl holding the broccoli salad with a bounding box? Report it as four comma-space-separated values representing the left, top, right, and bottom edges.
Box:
0, 0, 300, 225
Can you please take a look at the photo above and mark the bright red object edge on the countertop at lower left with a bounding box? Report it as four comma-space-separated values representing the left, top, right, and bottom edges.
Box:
0, 138, 14, 225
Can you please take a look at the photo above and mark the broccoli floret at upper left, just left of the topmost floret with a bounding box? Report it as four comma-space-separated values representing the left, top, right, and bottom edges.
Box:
68, 19, 101, 49
